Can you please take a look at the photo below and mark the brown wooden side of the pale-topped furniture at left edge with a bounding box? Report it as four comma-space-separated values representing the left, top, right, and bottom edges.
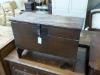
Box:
0, 40, 15, 75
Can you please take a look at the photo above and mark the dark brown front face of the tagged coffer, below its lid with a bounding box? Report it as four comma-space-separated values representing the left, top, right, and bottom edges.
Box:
12, 19, 81, 69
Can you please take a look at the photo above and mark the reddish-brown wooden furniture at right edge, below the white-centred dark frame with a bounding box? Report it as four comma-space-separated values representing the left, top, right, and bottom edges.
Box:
89, 32, 100, 75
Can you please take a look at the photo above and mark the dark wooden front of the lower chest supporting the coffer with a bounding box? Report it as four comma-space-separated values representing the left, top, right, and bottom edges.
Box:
10, 62, 57, 75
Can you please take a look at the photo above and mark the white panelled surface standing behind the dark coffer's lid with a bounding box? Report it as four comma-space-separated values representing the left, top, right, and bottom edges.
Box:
52, 0, 88, 18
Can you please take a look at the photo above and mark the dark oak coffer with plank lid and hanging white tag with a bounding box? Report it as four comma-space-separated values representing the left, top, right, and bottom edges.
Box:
10, 12, 84, 68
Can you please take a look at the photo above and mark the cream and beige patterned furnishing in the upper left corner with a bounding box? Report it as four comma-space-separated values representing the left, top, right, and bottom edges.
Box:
0, 1, 20, 26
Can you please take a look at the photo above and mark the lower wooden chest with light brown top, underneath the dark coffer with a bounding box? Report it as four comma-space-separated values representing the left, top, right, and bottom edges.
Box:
5, 48, 85, 75
